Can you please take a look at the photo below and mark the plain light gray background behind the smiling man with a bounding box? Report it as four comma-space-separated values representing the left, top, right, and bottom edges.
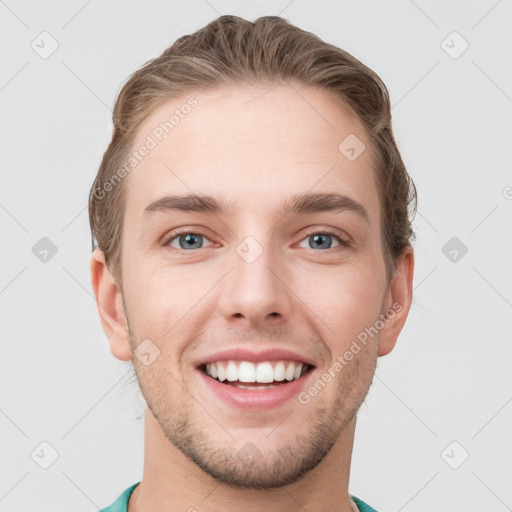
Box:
0, 0, 512, 512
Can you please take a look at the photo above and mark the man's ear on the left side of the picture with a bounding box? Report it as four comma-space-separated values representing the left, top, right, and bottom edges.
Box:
91, 249, 132, 361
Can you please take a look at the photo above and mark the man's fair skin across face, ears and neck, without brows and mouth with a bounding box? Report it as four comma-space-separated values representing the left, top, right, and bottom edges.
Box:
91, 85, 414, 512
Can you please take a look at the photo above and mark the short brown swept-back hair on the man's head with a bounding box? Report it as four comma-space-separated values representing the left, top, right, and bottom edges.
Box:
89, 16, 417, 285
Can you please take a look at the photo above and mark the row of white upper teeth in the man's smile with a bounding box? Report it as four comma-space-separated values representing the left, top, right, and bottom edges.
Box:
205, 360, 309, 389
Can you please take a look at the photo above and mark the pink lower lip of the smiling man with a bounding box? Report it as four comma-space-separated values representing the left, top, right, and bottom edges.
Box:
197, 370, 313, 410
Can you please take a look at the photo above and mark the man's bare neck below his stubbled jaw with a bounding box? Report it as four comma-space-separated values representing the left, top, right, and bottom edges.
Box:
128, 409, 356, 512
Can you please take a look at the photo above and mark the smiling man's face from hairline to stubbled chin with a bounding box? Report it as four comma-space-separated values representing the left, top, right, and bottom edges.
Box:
92, 85, 408, 488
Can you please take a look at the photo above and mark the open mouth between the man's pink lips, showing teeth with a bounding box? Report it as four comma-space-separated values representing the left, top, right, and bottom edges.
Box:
198, 359, 314, 391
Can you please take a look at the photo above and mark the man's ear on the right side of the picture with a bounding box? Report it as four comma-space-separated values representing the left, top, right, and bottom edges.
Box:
378, 247, 414, 356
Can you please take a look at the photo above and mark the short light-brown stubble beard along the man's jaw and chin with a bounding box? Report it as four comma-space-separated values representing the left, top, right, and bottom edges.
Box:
130, 334, 375, 490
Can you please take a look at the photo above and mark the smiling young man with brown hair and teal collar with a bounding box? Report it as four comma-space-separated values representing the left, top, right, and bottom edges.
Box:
90, 16, 416, 512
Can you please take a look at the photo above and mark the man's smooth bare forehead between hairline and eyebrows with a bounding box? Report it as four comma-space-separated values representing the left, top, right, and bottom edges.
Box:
126, 84, 378, 222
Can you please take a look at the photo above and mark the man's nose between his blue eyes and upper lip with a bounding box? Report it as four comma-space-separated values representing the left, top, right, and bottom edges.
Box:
219, 237, 293, 329
